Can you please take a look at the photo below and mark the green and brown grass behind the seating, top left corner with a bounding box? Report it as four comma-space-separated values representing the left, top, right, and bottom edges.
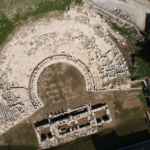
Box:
0, 0, 82, 45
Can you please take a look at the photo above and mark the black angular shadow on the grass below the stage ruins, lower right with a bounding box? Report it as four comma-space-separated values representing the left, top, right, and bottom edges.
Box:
91, 130, 150, 150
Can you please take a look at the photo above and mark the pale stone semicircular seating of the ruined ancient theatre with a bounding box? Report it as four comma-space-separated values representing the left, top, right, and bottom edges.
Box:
0, 0, 128, 133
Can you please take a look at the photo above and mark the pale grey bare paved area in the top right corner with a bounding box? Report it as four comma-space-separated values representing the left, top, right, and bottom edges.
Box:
92, 0, 150, 30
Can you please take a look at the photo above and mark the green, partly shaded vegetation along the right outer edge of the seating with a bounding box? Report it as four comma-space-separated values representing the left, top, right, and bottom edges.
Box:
110, 22, 150, 79
